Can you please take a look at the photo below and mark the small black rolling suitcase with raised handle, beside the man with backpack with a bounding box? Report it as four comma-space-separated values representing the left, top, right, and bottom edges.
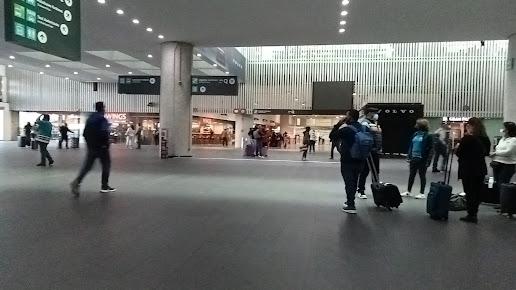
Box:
367, 157, 403, 211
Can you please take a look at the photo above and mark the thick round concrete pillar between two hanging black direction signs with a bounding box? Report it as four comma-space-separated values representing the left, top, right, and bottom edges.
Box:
159, 42, 193, 157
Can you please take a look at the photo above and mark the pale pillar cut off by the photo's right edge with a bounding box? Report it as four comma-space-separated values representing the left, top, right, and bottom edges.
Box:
503, 33, 516, 122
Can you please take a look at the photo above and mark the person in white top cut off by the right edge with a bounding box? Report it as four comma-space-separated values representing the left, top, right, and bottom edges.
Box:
491, 122, 516, 190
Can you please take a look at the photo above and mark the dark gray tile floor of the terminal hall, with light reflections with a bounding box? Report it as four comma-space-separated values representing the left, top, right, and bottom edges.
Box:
0, 143, 516, 289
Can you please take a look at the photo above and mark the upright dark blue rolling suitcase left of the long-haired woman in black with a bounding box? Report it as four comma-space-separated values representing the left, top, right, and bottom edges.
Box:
426, 146, 453, 220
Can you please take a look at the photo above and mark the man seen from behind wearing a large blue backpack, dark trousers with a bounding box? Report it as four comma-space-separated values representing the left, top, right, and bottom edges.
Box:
339, 110, 374, 214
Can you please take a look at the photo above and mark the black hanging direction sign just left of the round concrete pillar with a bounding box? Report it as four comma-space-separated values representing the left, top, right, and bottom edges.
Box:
118, 76, 161, 95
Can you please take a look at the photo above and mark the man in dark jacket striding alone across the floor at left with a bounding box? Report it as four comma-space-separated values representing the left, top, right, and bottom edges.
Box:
71, 102, 116, 197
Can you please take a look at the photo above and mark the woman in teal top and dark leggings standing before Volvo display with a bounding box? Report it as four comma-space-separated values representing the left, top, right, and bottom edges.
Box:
402, 119, 433, 199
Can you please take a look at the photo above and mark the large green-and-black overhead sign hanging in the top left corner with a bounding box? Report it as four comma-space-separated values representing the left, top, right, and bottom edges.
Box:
4, 0, 81, 61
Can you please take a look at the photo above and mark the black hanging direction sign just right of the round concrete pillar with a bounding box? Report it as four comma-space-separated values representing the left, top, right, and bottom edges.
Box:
192, 76, 238, 96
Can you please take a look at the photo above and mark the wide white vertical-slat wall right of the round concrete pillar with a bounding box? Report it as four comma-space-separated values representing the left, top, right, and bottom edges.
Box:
193, 40, 508, 118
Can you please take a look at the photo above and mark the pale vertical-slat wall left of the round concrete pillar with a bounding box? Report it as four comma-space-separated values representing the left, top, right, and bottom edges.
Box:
7, 69, 159, 113
